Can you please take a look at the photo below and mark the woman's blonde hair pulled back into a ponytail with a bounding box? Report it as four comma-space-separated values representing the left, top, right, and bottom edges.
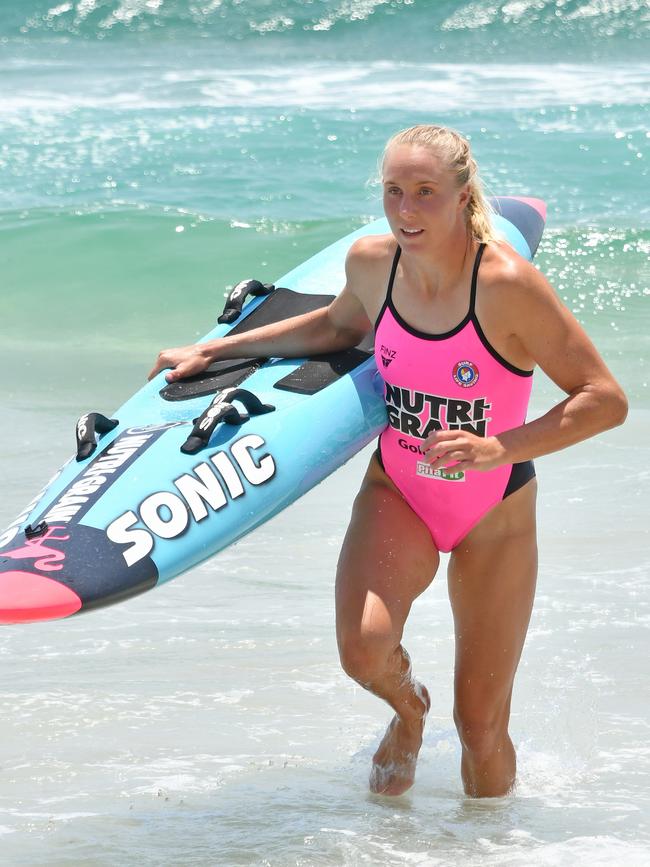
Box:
380, 123, 500, 243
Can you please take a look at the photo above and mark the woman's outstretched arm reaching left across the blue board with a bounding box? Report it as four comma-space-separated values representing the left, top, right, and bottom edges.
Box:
148, 245, 371, 382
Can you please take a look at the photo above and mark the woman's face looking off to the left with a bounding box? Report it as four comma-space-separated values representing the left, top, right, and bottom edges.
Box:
383, 144, 469, 250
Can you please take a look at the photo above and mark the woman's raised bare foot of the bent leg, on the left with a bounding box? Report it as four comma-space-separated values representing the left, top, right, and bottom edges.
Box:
370, 683, 431, 795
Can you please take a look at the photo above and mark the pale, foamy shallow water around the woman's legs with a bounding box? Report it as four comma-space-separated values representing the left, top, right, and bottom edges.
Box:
0, 413, 650, 865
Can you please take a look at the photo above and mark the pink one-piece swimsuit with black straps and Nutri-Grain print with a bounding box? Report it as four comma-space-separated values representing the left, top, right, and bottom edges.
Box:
375, 244, 535, 551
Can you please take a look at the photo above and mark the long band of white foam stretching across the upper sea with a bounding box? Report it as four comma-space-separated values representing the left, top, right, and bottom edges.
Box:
0, 61, 650, 117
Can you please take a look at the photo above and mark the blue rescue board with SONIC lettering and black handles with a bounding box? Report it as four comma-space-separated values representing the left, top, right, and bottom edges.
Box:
0, 197, 546, 623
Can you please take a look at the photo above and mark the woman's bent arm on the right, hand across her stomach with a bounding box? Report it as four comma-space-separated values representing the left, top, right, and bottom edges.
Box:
425, 262, 627, 470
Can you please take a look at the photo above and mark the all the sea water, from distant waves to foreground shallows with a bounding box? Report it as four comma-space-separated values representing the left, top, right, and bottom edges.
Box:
0, 0, 650, 867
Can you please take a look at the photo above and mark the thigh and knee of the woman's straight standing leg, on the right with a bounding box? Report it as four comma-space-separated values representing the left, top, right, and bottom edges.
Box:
448, 480, 537, 725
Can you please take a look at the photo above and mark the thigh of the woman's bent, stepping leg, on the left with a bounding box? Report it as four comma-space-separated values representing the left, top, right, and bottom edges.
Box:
336, 456, 439, 646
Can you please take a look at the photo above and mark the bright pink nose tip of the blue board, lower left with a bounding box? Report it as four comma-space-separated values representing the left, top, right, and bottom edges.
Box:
0, 570, 81, 623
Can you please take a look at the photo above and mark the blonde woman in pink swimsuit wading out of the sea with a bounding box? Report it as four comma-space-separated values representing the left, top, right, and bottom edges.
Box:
150, 125, 627, 797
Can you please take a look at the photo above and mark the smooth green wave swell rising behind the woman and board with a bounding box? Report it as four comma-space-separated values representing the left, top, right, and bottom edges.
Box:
0, 215, 650, 409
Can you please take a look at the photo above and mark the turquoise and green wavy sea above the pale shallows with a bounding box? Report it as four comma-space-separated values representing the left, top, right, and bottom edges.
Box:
0, 0, 650, 418
